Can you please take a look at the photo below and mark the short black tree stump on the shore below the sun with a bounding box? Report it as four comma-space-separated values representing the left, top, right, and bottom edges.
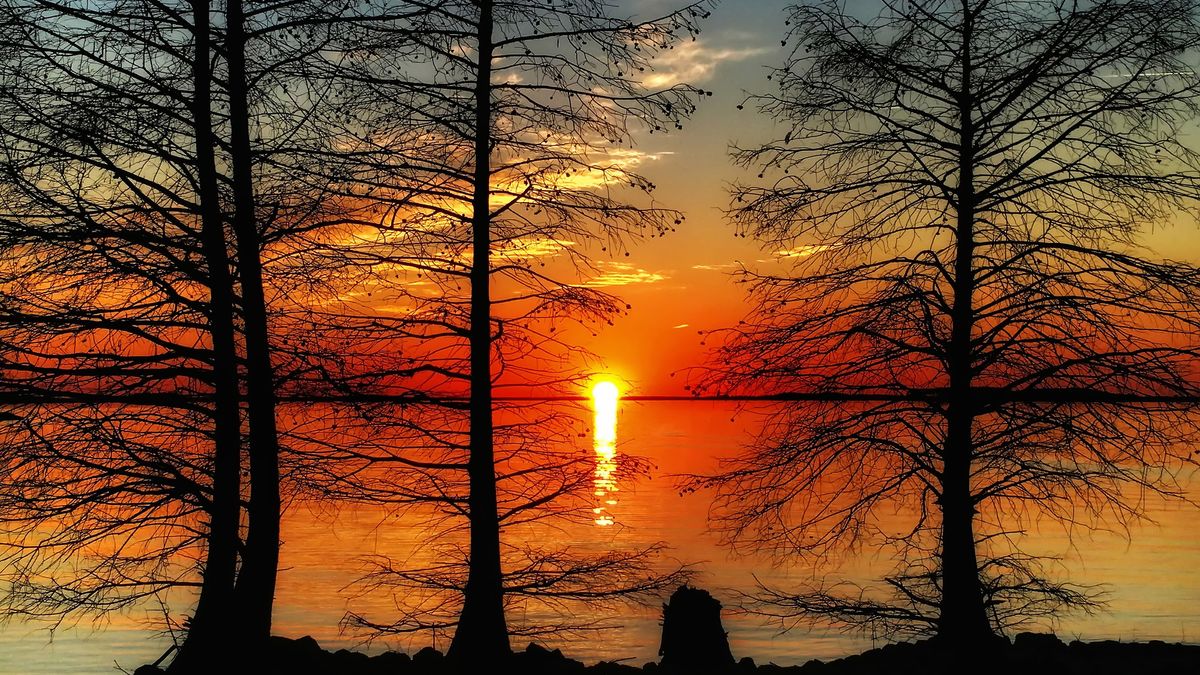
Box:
659, 585, 733, 673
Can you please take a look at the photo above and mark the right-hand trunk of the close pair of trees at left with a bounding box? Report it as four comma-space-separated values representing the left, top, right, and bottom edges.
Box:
226, 0, 280, 655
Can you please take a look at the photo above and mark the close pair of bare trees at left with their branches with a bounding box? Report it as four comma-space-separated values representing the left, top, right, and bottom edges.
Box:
0, 1, 350, 670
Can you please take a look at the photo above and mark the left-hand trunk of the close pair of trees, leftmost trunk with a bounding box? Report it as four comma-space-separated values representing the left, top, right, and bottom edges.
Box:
172, 0, 241, 673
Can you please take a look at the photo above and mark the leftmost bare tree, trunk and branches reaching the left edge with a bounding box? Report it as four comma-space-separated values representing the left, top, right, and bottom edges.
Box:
2, 2, 241, 655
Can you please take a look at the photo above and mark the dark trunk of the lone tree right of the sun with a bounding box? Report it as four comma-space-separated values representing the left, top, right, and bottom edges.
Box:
937, 2, 992, 645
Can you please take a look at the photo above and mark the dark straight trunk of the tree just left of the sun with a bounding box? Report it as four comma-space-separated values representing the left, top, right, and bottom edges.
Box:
449, 0, 510, 664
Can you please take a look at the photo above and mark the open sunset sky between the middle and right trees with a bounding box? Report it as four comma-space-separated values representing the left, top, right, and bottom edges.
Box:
578, 0, 788, 395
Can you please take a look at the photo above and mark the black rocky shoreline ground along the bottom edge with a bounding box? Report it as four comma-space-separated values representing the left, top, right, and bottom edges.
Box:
134, 633, 1200, 675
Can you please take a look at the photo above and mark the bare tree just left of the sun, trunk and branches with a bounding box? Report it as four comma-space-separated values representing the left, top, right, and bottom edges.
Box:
314, 0, 704, 662
